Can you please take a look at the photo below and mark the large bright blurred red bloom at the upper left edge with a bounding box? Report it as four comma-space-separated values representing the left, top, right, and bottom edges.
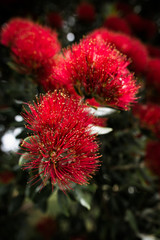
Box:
1, 18, 61, 73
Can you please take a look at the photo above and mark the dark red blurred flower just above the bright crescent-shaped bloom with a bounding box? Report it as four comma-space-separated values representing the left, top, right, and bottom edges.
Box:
103, 16, 131, 35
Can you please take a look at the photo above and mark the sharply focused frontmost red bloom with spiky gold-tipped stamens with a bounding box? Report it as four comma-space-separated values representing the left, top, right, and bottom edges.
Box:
22, 91, 99, 190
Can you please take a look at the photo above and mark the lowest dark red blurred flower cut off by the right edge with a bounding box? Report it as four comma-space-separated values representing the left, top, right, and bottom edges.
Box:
145, 141, 160, 176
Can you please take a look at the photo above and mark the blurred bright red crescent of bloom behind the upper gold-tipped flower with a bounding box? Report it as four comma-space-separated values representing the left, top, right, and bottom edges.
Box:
88, 28, 148, 74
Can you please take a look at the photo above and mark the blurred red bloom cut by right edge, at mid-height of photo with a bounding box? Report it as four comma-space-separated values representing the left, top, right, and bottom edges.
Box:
133, 103, 160, 138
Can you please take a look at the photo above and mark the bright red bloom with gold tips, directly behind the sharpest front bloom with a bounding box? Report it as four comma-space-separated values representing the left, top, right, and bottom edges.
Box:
53, 38, 139, 109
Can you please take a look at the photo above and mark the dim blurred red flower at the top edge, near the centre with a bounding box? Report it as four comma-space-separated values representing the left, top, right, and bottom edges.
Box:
76, 2, 95, 22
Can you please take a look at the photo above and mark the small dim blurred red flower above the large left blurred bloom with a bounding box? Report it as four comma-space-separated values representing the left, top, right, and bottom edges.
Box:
46, 12, 63, 28
